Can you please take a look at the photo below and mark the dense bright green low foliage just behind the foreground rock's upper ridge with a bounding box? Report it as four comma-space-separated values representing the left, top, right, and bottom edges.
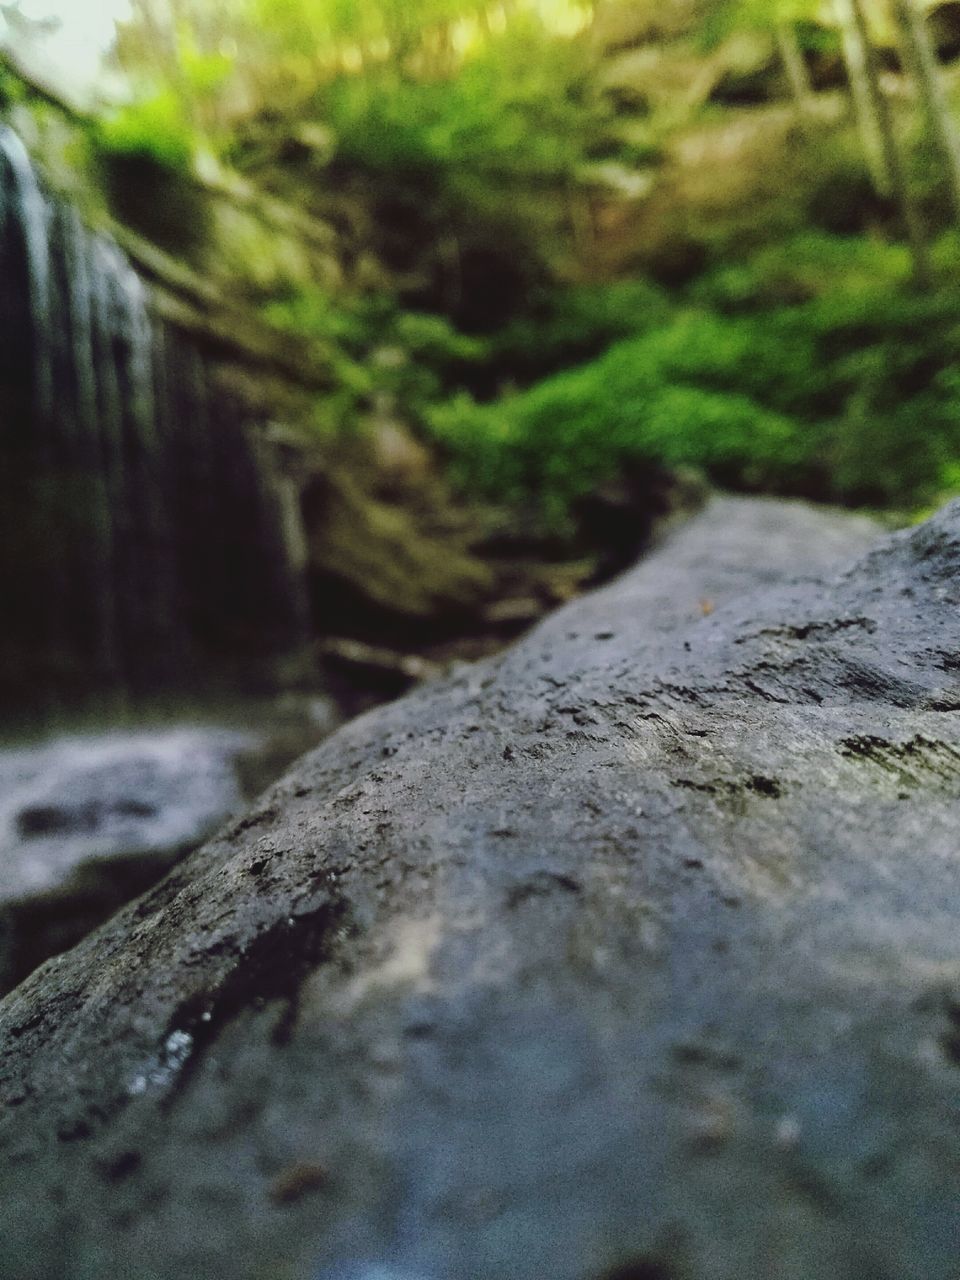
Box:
430, 237, 960, 525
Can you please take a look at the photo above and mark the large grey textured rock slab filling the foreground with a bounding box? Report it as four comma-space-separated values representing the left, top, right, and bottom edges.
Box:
0, 500, 960, 1280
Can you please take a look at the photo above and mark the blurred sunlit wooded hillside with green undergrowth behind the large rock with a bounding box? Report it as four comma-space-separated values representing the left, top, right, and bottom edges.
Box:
5, 0, 960, 535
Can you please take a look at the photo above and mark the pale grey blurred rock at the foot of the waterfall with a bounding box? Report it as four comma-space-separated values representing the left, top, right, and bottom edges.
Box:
0, 728, 256, 991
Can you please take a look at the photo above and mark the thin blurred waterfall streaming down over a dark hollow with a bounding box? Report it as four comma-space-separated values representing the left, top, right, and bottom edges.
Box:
0, 125, 305, 721
